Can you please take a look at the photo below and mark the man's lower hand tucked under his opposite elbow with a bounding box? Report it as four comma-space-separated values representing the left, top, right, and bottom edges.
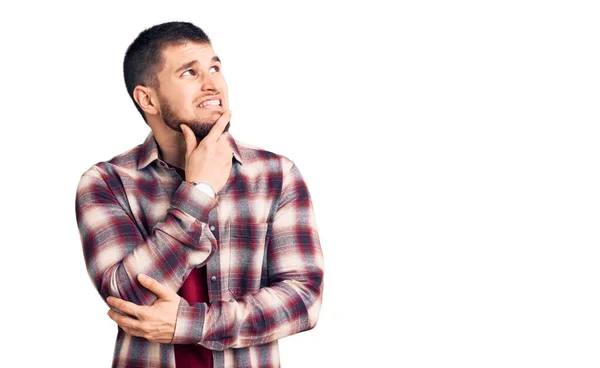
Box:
106, 274, 181, 344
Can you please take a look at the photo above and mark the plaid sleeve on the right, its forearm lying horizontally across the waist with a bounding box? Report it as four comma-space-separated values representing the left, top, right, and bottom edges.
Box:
172, 164, 324, 350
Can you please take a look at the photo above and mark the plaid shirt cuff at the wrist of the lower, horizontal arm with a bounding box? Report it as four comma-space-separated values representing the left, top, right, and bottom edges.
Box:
171, 298, 207, 344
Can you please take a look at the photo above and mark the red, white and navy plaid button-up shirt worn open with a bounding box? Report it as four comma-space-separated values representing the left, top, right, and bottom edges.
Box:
76, 132, 323, 367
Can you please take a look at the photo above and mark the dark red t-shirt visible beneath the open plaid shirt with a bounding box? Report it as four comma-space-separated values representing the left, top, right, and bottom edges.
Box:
169, 165, 213, 368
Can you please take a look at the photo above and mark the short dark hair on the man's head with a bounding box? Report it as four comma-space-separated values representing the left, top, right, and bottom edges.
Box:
123, 22, 211, 123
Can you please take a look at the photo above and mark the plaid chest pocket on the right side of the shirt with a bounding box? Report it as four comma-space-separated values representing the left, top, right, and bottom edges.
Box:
227, 222, 269, 298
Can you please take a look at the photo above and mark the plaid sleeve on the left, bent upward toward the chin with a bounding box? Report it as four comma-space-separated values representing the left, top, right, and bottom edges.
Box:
75, 166, 218, 305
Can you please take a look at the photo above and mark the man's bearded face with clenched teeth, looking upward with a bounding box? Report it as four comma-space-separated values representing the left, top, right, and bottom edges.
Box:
157, 42, 229, 139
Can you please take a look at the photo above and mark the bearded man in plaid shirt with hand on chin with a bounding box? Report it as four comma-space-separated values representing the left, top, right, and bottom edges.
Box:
76, 22, 323, 368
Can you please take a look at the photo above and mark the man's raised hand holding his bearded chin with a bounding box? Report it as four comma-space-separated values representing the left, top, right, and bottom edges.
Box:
180, 110, 233, 193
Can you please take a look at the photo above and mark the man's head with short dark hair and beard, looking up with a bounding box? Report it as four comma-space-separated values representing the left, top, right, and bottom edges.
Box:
123, 22, 229, 139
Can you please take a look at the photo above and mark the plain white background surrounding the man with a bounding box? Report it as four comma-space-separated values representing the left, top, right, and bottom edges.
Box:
0, 0, 600, 368
